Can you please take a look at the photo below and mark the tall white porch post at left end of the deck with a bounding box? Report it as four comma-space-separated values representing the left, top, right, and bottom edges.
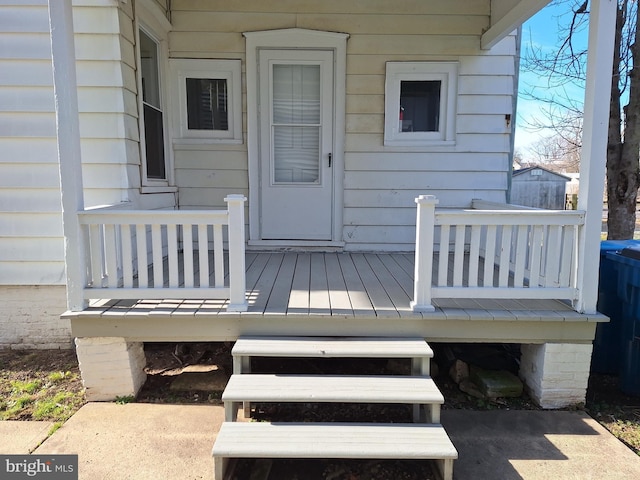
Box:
49, 0, 86, 311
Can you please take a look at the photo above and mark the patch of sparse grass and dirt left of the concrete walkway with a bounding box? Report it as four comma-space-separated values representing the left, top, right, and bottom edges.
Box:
0, 351, 85, 429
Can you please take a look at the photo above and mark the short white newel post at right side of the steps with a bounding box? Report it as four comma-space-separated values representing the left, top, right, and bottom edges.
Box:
411, 195, 438, 312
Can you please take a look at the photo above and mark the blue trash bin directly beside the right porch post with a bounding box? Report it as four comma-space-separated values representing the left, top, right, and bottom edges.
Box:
591, 240, 640, 375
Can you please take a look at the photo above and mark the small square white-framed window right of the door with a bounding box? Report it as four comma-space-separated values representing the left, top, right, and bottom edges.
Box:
384, 62, 458, 146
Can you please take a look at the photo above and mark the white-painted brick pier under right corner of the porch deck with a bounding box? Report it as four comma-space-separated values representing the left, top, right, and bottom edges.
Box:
520, 343, 593, 409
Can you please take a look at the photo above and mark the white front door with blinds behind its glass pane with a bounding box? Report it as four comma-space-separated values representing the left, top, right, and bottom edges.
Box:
259, 50, 334, 240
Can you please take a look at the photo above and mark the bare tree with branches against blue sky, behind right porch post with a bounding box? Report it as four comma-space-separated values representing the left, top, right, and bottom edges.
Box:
522, 0, 640, 240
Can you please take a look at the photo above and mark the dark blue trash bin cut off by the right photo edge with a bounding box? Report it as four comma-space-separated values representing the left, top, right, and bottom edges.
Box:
606, 246, 640, 395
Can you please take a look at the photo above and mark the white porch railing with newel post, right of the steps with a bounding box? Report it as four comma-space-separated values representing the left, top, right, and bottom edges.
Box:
412, 195, 584, 311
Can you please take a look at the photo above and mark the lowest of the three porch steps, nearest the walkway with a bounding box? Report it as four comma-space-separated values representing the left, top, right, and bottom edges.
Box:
212, 422, 458, 480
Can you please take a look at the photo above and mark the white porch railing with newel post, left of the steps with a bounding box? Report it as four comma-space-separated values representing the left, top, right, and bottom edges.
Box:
79, 195, 247, 311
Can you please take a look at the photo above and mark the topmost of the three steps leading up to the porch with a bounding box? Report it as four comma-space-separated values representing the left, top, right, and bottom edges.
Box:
231, 336, 433, 375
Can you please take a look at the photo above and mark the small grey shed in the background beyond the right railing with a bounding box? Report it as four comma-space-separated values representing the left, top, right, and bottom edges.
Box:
510, 166, 571, 210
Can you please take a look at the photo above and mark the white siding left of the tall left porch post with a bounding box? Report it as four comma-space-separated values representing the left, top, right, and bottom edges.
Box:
0, 1, 64, 285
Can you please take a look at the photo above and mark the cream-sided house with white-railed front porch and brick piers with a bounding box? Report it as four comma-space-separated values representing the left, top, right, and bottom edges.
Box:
0, 0, 615, 420
